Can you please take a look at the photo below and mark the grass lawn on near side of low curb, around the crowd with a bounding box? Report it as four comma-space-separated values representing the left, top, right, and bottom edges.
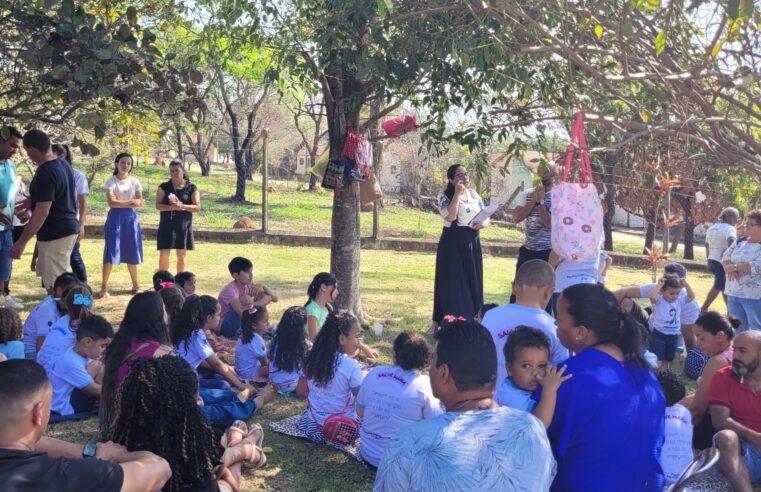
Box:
11, 239, 719, 491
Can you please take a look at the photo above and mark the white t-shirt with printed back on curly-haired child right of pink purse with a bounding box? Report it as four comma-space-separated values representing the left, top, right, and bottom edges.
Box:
357, 366, 444, 466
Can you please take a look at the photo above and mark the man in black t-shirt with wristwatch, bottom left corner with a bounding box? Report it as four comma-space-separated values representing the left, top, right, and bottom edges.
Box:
0, 359, 172, 492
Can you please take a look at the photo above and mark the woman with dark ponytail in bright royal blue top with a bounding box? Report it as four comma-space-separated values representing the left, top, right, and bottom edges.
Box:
547, 284, 666, 492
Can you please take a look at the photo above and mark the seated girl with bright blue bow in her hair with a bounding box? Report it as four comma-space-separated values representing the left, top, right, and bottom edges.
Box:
37, 284, 92, 375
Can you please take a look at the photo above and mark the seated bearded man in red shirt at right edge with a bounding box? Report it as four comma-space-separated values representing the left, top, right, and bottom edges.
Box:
708, 331, 761, 492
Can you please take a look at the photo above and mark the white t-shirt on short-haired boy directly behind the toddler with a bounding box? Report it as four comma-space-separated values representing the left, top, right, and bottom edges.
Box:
482, 304, 568, 381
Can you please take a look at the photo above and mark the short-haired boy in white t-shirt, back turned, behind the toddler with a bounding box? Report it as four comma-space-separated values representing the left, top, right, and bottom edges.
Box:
482, 260, 568, 381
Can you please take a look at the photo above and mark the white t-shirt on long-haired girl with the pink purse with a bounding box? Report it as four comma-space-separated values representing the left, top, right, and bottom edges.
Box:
306, 352, 363, 425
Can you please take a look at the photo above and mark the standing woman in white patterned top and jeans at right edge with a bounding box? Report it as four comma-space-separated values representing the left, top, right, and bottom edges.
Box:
721, 209, 761, 330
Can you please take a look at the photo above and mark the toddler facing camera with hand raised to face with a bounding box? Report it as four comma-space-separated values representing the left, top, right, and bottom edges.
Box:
494, 326, 571, 428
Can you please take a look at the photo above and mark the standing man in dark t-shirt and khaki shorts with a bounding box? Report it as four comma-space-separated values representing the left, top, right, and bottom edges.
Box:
10, 129, 79, 290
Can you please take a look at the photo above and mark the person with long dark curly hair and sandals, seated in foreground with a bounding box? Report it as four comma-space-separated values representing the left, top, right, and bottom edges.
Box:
113, 355, 267, 492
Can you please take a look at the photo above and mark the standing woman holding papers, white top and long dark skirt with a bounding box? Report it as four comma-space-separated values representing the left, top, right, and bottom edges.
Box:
432, 164, 489, 329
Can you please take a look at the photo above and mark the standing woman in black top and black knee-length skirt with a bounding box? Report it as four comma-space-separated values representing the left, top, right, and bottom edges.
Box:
156, 161, 201, 273
